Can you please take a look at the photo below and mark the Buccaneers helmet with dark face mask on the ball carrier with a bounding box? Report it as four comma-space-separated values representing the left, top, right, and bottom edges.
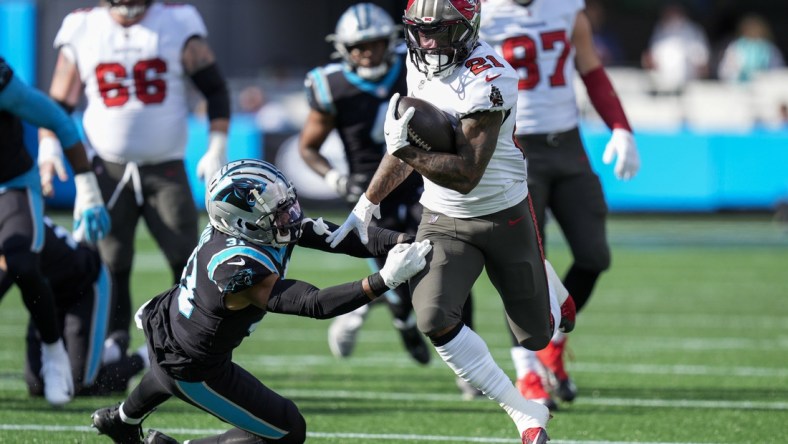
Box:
402, 0, 481, 78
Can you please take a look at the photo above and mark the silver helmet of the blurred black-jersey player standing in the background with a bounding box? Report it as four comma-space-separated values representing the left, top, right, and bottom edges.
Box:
326, 3, 400, 80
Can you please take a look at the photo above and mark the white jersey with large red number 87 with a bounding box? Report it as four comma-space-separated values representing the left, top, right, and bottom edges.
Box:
479, 0, 585, 135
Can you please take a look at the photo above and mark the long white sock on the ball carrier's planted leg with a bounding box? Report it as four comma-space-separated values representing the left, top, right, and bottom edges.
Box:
435, 326, 550, 434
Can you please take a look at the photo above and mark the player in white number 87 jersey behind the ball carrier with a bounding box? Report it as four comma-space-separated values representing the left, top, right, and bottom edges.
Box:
480, 0, 640, 408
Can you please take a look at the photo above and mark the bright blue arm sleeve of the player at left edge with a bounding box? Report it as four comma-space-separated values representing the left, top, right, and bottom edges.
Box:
0, 76, 80, 149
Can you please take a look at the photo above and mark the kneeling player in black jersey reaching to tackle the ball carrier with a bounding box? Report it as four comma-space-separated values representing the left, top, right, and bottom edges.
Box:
92, 159, 431, 444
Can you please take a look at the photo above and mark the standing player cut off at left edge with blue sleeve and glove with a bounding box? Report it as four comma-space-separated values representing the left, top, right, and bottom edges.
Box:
0, 57, 110, 405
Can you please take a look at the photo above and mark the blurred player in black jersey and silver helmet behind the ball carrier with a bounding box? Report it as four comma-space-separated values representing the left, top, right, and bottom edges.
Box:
299, 3, 475, 372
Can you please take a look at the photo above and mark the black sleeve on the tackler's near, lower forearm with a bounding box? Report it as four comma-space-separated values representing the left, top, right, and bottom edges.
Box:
268, 279, 377, 319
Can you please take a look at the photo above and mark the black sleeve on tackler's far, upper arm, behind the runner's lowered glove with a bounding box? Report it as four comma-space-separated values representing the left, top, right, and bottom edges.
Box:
298, 221, 415, 258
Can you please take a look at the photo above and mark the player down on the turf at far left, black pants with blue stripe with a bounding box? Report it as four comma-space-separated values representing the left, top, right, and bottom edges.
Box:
0, 217, 148, 396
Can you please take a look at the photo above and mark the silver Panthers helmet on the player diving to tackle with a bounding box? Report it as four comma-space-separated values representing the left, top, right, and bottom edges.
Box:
205, 159, 304, 248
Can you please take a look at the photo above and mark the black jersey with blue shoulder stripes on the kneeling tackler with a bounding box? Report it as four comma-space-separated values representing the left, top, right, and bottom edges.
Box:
146, 225, 292, 380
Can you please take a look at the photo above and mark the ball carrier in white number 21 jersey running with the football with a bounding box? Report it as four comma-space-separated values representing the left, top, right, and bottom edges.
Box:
327, 0, 560, 444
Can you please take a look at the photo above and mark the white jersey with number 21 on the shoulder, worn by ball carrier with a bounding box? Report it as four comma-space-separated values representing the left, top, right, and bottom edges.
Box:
407, 42, 528, 218
